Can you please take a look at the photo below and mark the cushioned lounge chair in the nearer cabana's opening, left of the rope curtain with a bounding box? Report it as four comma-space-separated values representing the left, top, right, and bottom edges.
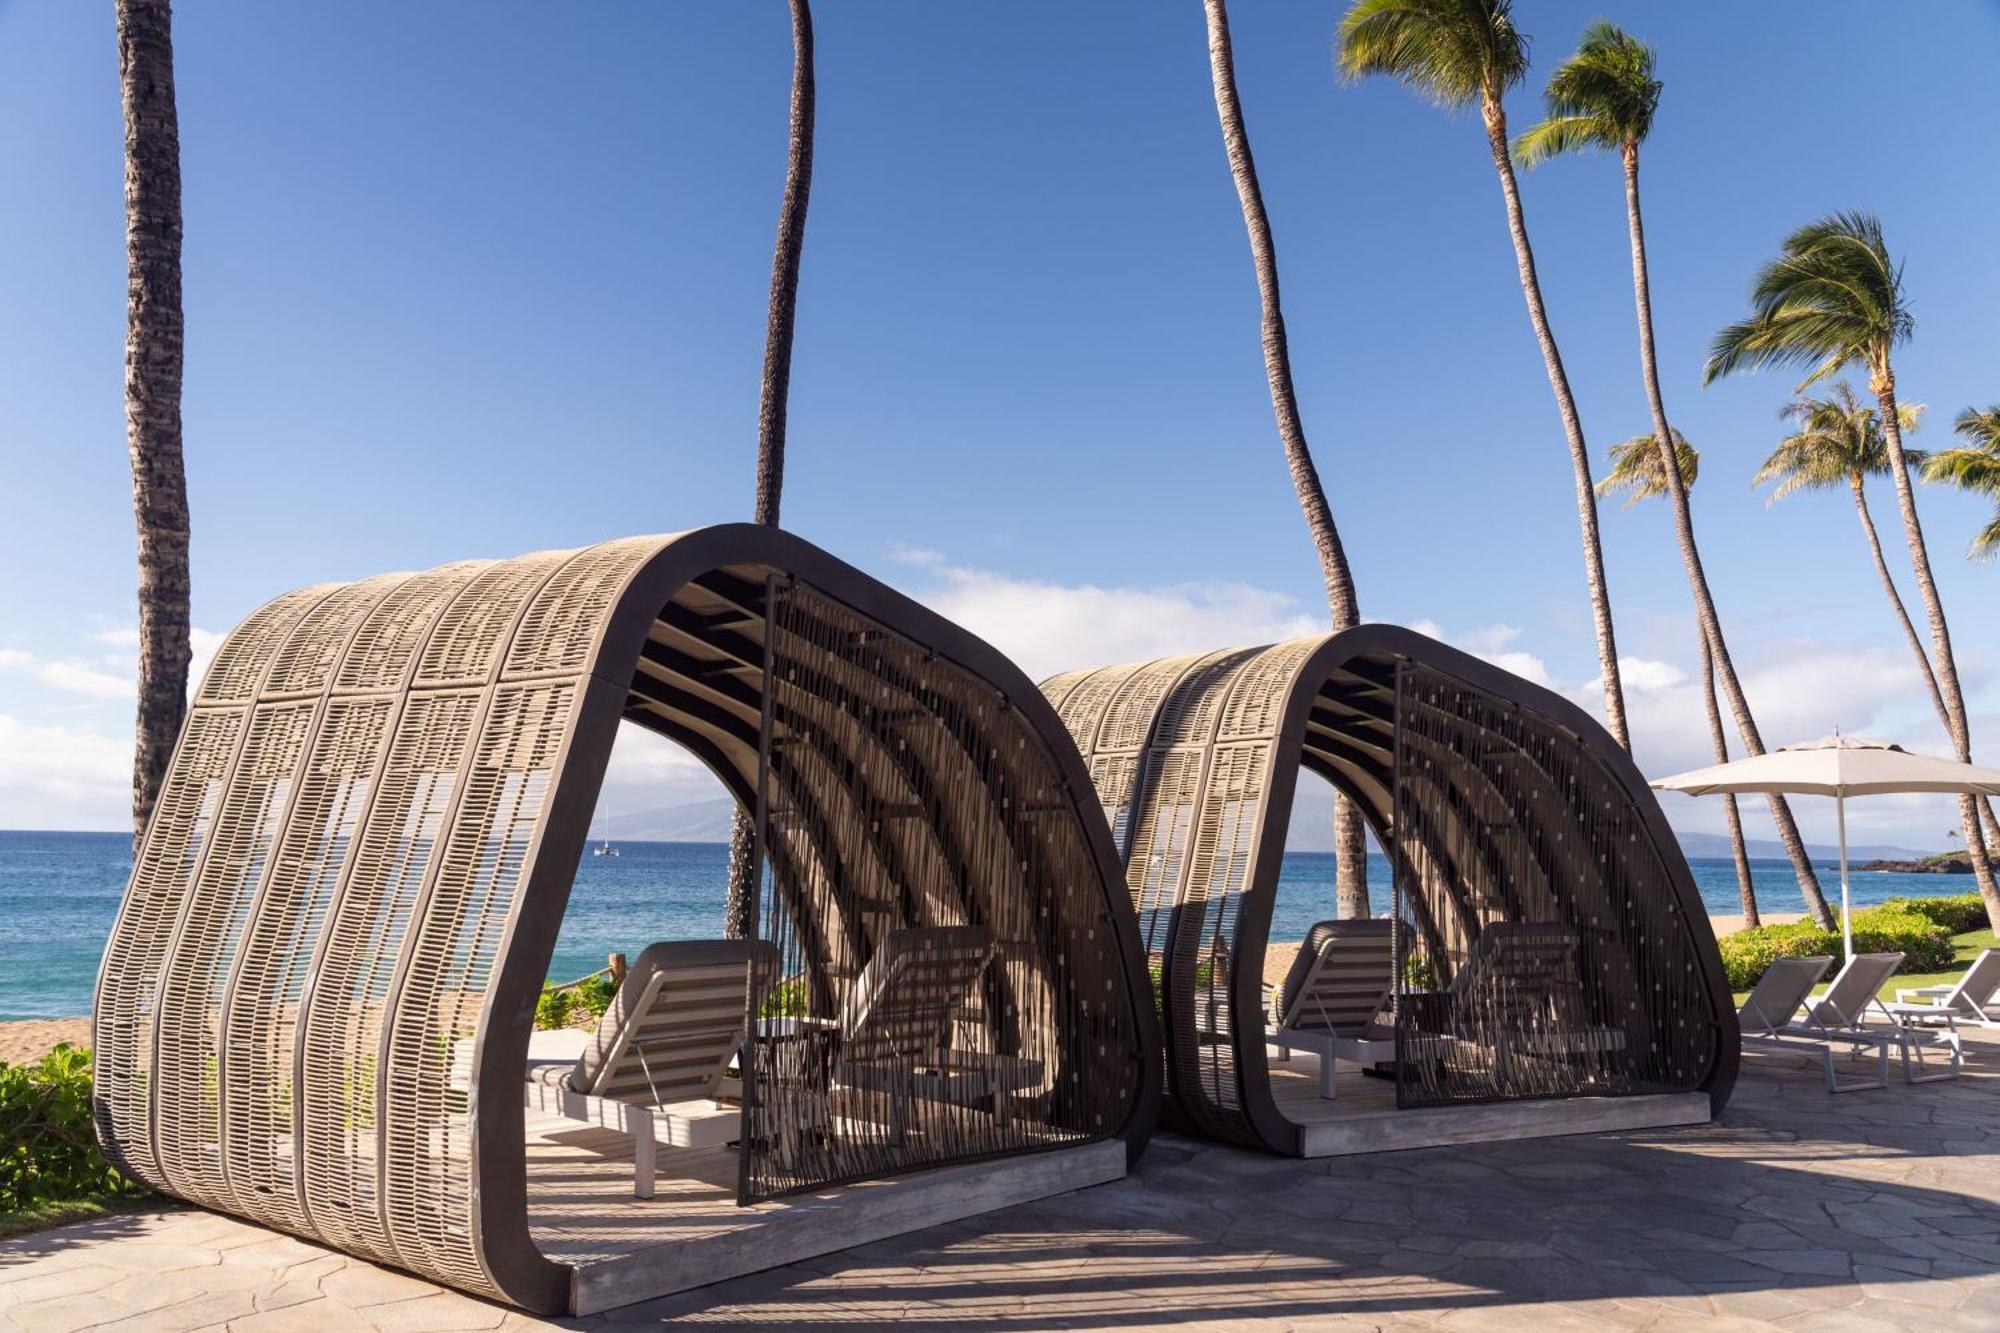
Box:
528, 939, 778, 1199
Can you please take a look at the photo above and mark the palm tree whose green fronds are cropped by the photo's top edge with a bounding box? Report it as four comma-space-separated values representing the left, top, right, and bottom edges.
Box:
1338, 0, 1632, 749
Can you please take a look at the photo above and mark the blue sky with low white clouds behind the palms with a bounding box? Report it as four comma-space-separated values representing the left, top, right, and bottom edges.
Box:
0, 0, 2000, 843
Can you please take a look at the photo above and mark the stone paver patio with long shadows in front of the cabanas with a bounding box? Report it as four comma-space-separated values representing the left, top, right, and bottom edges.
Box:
0, 1035, 2000, 1333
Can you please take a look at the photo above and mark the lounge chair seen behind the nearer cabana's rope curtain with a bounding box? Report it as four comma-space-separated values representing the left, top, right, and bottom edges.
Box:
834, 927, 1042, 1143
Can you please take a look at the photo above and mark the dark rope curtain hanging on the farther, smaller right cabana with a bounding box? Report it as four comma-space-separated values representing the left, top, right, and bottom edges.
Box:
1390, 662, 1716, 1109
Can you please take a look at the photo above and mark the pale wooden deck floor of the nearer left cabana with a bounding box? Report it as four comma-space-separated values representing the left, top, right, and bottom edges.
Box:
528, 1111, 1126, 1315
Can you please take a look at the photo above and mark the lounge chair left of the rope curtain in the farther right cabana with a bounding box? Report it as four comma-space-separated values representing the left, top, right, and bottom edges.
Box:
1268, 919, 1396, 1101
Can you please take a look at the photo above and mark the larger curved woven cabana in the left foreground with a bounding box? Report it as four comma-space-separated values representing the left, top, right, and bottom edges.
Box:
94, 524, 1160, 1313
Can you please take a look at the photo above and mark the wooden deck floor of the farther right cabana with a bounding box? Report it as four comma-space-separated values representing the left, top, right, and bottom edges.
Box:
1270, 1051, 1708, 1157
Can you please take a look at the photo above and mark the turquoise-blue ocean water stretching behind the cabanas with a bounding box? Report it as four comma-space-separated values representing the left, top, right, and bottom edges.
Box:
0, 831, 1972, 1021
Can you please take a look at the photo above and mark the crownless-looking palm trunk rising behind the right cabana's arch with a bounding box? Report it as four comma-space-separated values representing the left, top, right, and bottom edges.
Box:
1204, 0, 1368, 917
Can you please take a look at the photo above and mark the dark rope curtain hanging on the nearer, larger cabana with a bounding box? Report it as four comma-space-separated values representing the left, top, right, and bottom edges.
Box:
738, 578, 1138, 1203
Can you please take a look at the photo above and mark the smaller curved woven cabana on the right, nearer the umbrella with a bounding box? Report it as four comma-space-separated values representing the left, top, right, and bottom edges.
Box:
1042, 624, 1738, 1157
